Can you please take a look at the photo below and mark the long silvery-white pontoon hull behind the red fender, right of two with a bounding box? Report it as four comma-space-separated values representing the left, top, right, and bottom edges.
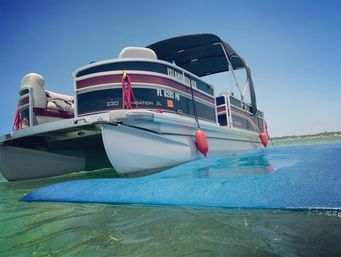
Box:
101, 112, 261, 176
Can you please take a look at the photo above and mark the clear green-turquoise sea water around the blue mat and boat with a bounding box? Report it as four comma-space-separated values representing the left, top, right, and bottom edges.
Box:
0, 137, 341, 256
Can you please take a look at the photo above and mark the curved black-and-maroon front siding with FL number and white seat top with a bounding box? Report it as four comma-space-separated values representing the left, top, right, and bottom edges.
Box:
74, 47, 216, 122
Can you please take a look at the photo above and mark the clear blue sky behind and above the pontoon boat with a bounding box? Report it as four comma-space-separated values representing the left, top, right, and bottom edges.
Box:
0, 0, 341, 136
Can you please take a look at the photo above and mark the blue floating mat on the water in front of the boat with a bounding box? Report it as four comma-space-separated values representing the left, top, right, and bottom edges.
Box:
22, 144, 341, 210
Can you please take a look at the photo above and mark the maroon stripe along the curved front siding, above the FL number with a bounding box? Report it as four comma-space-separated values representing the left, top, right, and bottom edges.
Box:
76, 74, 214, 103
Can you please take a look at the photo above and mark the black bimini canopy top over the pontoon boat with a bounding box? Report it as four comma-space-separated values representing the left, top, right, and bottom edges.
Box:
147, 34, 257, 115
